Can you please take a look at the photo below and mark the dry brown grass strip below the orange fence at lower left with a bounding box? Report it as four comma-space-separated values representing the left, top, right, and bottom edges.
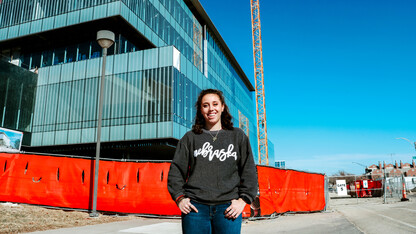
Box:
0, 202, 137, 233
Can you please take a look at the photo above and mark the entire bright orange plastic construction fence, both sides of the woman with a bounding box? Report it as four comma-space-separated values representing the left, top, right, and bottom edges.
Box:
0, 153, 325, 217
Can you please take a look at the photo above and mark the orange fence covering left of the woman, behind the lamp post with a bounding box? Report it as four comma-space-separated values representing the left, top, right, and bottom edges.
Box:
0, 153, 180, 215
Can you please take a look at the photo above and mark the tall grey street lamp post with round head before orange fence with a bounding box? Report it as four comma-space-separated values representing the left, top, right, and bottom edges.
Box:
90, 30, 115, 217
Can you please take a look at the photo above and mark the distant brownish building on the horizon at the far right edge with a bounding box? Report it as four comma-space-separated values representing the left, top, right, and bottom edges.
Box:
366, 160, 416, 179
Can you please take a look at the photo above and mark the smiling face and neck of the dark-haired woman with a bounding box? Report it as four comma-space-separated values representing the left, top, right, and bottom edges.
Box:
201, 93, 224, 130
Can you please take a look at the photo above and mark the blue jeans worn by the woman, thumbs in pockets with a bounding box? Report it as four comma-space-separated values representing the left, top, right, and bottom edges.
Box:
182, 200, 243, 234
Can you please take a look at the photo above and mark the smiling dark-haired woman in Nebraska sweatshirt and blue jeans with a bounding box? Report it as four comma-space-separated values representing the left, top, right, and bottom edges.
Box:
168, 89, 257, 233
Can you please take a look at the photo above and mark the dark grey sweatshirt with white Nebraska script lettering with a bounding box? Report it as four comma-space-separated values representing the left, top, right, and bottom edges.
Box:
168, 128, 258, 205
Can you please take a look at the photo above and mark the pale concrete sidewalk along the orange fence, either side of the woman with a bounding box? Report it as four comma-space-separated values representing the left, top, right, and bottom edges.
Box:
29, 211, 361, 234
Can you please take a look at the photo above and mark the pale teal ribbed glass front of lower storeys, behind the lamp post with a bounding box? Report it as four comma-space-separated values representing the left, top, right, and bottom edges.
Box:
32, 47, 179, 146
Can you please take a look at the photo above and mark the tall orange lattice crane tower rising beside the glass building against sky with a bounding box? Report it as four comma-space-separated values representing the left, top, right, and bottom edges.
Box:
250, 0, 269, 165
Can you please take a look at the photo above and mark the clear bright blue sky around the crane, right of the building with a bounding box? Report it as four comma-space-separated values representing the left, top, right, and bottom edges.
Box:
200, 0, 416, 175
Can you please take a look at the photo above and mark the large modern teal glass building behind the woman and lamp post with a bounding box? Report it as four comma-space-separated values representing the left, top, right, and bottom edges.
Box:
0, 0, 272, 164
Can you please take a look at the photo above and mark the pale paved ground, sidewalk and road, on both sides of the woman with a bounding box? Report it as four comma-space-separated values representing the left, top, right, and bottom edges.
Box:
30, 196, 416, 234
